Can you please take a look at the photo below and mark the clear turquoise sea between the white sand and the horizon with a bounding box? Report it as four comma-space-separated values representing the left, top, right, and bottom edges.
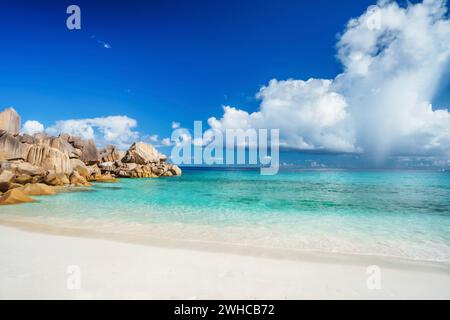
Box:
0, 168, 450, 261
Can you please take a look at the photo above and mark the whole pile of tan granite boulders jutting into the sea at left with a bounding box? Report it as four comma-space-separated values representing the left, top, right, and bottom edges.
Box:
0, 109, 181, 204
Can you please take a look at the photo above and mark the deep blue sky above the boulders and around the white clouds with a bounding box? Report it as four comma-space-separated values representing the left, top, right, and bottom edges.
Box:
0, 0, 450, 168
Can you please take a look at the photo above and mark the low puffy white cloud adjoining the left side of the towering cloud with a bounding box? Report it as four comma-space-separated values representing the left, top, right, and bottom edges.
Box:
208, 79, 356, 152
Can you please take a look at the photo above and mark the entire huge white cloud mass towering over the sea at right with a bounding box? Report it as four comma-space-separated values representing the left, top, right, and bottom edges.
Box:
208, 0, 450, 158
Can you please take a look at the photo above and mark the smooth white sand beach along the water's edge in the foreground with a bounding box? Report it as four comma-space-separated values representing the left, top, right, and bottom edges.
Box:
0, 226, 450, 299
